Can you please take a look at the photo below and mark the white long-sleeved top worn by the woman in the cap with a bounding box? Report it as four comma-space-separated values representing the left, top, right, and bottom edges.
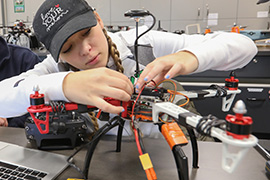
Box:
0, 26, 257, 117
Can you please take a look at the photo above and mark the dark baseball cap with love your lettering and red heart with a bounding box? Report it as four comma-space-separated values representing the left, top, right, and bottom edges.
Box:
33, 0, 97, 62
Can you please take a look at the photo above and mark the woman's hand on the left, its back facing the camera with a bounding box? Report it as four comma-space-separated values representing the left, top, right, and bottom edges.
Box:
63, 67, 134, 114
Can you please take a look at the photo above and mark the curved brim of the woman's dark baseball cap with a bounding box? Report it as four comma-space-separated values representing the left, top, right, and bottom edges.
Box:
49, 11, 97, 62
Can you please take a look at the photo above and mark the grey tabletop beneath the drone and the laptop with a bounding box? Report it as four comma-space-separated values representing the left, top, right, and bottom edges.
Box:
0, 127, 268, 180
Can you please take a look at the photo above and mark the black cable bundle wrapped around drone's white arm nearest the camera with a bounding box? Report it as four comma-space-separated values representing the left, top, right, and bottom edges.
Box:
196, 114, 226, 136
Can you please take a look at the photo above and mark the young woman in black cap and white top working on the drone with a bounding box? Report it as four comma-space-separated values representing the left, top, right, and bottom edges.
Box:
0, 0, 257, 121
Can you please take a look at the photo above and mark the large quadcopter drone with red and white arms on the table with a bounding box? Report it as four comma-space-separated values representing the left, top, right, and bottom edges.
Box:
26, 10, 258, 180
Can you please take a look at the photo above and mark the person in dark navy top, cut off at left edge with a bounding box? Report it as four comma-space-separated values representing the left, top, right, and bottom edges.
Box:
0, 36, 40, 127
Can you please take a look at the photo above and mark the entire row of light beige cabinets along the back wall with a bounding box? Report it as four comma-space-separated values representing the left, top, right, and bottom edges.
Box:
0, 0, 270, 36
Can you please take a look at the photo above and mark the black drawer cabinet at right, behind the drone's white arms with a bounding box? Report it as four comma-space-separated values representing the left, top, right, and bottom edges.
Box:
176, 49, 270, 139
